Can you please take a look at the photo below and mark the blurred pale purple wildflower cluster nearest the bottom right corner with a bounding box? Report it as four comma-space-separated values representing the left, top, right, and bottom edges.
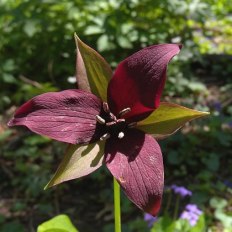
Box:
180, 204, 202, 226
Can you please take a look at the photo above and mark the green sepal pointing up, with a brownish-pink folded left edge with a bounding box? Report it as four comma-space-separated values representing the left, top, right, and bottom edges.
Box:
74, 34, 113, 101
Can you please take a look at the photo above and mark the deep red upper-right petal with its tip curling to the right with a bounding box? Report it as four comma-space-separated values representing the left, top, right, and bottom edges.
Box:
107, 44, 181, 121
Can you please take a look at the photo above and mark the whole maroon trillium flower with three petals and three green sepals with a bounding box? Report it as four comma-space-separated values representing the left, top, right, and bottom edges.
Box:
8, 37, 208, 216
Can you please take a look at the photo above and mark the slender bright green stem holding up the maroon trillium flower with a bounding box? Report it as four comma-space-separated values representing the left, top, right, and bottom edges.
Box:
114, 178, 121, 232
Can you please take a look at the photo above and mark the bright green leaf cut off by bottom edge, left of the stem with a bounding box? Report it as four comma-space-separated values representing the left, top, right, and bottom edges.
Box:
37, 214, 78, 232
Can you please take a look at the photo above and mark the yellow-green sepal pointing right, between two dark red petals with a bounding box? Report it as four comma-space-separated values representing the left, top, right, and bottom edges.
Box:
138, 102, 209, 139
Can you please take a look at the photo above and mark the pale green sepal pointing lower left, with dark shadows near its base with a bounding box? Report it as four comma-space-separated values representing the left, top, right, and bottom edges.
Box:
45, 141, 105, 189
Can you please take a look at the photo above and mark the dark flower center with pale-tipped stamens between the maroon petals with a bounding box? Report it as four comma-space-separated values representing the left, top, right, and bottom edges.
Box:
96, 102, 136, 140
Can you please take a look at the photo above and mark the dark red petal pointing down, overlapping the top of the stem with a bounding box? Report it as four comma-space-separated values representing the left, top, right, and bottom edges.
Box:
105, 129, 164, 216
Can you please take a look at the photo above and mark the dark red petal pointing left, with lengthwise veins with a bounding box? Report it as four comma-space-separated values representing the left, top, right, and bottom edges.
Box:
8, 90, 102, 144
